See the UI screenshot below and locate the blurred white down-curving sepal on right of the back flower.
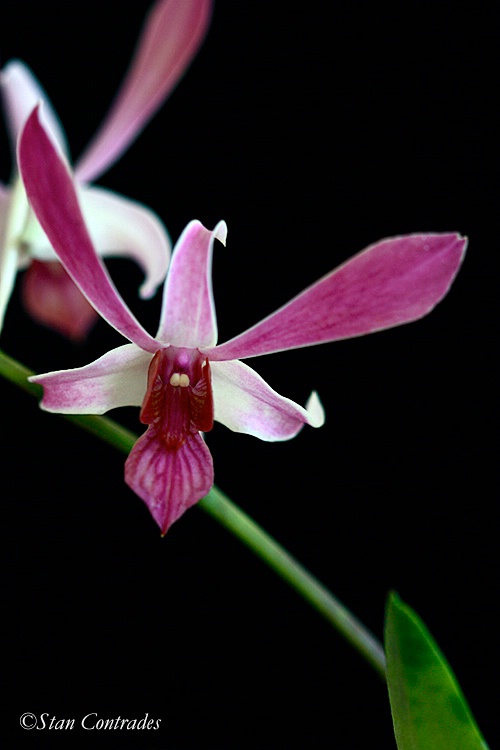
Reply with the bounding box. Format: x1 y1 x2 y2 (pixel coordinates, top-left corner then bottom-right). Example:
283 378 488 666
78 187 172 299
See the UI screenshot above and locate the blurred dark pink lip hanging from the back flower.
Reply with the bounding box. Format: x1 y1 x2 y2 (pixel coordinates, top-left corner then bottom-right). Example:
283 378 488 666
22 260 98 341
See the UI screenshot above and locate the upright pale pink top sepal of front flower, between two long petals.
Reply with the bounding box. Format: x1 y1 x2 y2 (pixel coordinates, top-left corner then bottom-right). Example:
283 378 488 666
156 221 227 348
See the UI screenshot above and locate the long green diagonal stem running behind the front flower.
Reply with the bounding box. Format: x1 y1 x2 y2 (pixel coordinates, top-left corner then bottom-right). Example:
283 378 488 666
0 351 385 679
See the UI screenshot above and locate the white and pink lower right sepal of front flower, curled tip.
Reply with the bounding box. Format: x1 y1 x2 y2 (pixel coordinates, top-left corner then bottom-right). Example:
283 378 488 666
212 360 325 441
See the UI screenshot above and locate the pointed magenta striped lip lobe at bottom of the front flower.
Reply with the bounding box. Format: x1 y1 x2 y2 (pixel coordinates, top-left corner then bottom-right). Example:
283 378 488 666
125 427 214 534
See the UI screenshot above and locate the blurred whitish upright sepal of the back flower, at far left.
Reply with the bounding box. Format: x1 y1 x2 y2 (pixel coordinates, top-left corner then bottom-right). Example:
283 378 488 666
0 60 68 160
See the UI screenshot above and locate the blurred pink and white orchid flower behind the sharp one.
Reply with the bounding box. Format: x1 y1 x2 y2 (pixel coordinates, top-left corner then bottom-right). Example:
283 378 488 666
0 0 212 340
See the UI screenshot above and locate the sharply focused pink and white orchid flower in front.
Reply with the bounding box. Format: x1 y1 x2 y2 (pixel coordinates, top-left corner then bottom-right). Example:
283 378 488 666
19 111 466 533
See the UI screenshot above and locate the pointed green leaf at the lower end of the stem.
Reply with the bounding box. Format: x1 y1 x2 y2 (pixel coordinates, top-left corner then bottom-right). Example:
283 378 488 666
385 593 488 750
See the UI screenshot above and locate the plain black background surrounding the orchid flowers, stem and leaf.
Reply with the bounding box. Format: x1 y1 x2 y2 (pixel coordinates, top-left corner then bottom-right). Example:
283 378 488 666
0 0 499 750
